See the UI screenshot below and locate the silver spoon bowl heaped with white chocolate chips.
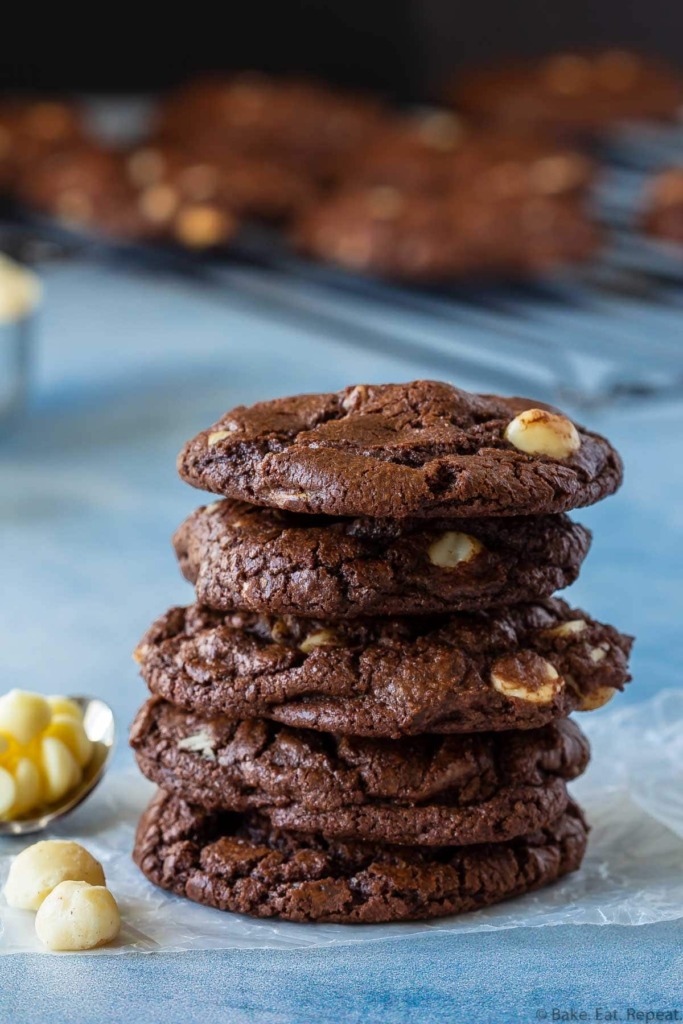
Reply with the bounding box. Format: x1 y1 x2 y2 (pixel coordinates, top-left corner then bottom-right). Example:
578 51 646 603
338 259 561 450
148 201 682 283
0 690 116 837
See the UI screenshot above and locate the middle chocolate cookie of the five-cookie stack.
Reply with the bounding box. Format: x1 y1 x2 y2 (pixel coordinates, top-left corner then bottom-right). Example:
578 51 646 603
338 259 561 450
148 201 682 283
135 599 632 737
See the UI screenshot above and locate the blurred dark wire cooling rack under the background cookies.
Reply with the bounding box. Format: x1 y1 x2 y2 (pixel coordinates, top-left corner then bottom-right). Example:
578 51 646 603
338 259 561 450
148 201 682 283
0 117 683 404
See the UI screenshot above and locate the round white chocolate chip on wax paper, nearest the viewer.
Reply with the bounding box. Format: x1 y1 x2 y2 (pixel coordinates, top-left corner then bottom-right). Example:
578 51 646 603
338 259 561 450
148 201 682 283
36 882 121 950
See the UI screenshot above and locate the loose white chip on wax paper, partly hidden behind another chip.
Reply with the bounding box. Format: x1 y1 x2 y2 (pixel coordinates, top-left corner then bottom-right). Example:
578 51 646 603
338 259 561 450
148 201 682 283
5 840 104 910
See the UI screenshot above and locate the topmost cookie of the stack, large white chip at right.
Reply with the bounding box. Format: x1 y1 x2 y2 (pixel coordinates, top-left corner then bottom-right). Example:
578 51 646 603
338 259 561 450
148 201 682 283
178 381 622 518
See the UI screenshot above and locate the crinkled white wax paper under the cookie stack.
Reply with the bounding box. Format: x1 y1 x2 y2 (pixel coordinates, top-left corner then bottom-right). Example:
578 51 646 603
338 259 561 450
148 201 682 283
0 690 683 953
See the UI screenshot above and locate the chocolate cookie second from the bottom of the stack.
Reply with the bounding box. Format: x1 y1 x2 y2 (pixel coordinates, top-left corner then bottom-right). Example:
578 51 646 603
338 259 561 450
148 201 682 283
130 699 589 846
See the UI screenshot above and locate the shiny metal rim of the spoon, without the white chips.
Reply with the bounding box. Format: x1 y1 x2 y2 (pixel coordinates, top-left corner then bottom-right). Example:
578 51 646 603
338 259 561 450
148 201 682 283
0 696 116 836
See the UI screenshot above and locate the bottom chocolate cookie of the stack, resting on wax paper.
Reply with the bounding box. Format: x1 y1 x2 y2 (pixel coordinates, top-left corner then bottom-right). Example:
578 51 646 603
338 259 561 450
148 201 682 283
133 793 588 924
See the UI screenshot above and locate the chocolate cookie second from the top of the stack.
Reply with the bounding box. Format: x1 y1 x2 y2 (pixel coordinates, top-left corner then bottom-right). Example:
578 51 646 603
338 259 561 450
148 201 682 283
173 499 591 618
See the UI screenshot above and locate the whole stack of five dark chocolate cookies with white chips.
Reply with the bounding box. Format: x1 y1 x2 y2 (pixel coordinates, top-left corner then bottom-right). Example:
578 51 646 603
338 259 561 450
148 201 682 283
131 381 631 922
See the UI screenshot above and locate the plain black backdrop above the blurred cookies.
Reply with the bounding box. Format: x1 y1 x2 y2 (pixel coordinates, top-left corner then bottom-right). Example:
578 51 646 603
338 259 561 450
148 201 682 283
0 0 683 98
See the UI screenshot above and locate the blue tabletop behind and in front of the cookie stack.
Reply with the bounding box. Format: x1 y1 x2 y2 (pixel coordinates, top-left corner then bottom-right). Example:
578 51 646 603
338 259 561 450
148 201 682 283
0 263 683 1024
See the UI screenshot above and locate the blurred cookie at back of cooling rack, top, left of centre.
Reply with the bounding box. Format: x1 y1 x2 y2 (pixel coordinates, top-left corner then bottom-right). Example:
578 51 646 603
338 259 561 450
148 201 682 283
156 73 383 179
